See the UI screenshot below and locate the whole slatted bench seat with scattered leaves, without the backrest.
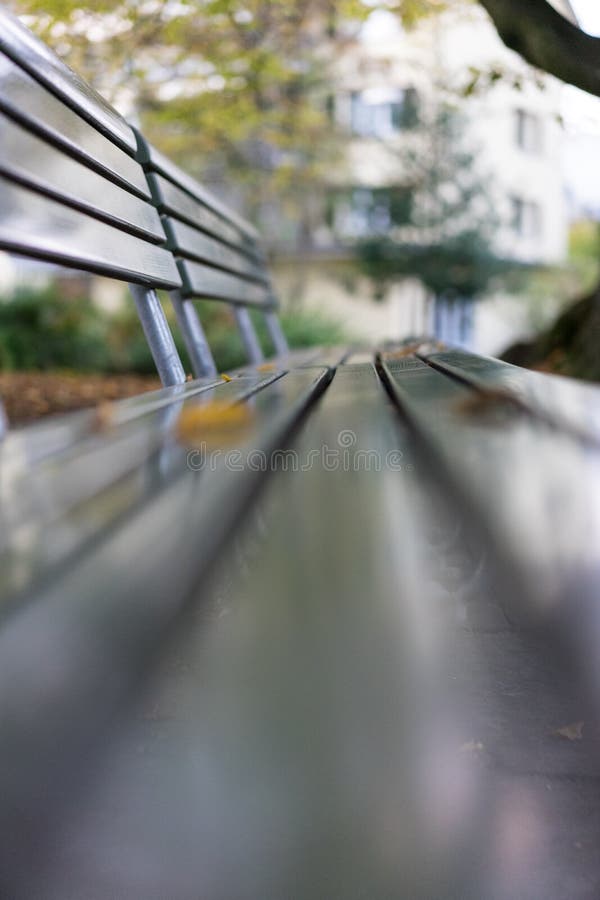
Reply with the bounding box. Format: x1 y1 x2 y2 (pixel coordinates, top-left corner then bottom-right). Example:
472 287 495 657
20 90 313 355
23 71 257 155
0 351 600 900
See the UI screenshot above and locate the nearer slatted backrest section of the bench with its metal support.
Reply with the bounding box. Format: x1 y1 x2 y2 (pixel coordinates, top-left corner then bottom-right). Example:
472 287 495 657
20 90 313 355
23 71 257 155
0 10 190 384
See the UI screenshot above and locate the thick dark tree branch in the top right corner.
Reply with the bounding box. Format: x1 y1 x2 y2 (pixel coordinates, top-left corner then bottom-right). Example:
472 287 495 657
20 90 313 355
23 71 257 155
479 0 600 96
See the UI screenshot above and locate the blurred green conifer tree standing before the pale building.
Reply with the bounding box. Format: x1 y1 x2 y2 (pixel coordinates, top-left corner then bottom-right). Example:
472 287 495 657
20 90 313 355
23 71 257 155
357 107 514 300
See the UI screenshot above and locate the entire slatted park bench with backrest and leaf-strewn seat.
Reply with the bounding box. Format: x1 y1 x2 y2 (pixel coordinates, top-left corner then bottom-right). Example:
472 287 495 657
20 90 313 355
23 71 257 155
0 12 600 900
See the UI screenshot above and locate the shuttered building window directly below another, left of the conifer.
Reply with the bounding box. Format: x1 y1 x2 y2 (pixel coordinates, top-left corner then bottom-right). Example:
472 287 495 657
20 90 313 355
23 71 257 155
327 187 412 239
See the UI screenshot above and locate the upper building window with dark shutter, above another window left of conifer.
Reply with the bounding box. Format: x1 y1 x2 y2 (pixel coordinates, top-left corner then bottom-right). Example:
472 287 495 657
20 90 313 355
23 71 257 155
350 87 418 138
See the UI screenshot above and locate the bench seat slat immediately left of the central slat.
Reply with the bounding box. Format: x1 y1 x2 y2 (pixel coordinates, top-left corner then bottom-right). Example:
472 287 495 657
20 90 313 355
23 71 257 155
0 369 330 896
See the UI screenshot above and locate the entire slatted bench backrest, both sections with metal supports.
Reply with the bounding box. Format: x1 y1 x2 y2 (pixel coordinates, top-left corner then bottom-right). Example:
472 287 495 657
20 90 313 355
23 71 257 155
0 9 287 398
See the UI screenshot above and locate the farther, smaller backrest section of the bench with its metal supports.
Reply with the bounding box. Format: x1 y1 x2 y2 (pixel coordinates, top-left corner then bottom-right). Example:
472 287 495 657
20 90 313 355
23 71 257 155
138 135 287 375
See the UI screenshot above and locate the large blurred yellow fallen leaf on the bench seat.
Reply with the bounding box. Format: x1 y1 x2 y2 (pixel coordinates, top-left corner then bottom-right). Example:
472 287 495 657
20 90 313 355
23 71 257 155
176 400 254 447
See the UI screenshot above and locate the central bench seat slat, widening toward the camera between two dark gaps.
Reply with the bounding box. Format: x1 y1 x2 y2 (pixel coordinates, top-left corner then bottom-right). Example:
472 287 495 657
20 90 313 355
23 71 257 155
57 371 599 900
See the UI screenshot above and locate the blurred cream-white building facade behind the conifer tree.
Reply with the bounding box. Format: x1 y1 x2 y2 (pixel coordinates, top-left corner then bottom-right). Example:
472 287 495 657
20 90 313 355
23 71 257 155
275 2 572 352
